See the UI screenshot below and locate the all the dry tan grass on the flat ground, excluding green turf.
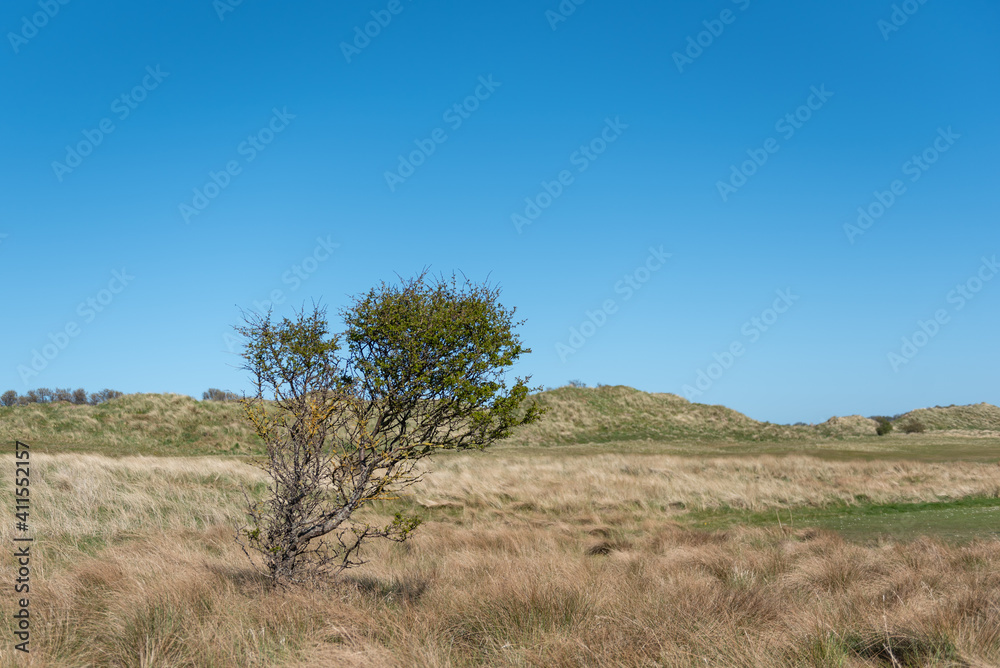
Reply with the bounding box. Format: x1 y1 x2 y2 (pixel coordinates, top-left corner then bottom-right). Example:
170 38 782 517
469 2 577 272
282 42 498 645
0 451 1000 668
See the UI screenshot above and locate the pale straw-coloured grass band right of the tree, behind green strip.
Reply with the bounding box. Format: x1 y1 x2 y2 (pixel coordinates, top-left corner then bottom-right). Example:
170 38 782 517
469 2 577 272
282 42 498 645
415 450 1000 515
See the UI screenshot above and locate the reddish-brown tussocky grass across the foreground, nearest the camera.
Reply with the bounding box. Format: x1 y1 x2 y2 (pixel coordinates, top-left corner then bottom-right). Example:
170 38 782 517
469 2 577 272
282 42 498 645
2 522 1000 668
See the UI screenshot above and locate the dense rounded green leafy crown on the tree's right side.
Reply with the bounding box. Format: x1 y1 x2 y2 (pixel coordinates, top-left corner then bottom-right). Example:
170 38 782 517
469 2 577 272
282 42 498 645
342 272 541 449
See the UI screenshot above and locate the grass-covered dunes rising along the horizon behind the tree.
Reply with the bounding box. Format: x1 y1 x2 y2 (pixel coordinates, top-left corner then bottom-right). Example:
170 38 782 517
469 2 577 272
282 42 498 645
0 385 1000 455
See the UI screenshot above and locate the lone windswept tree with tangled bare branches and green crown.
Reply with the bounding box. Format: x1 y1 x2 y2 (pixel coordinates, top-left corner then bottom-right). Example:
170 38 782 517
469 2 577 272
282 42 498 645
236 271 542 584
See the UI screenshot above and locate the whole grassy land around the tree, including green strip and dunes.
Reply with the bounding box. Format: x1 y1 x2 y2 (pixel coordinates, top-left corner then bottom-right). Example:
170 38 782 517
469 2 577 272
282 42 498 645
0 388 1000 668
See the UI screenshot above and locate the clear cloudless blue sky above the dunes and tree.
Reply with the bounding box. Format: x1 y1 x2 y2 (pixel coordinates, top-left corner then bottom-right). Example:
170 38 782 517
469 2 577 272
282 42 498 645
0 0 1000 422
